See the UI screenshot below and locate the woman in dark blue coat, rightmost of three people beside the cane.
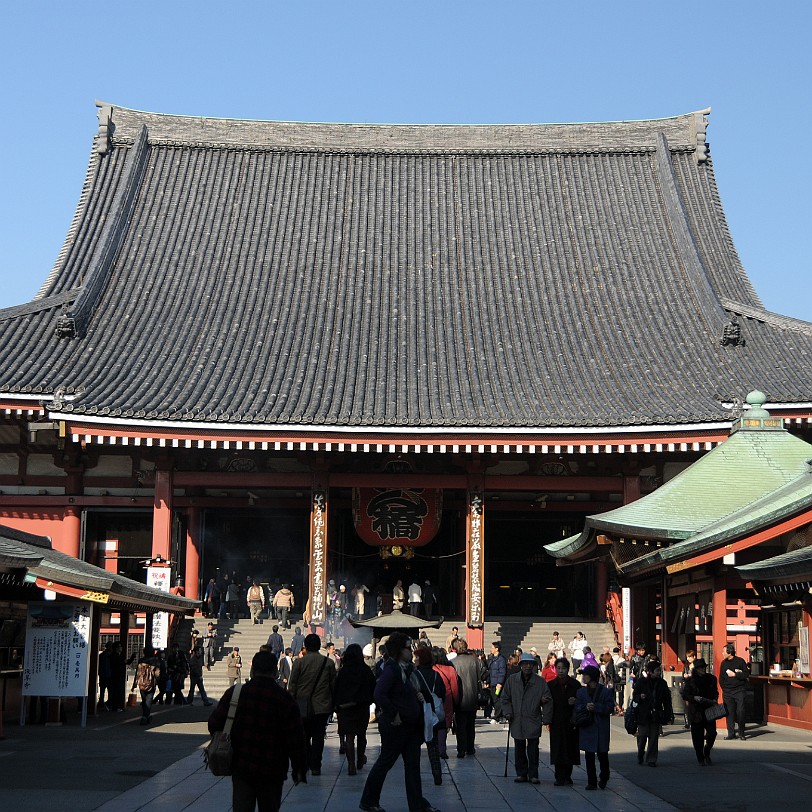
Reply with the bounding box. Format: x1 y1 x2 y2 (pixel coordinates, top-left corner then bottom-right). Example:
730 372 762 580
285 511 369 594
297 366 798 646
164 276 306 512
572 665 615 789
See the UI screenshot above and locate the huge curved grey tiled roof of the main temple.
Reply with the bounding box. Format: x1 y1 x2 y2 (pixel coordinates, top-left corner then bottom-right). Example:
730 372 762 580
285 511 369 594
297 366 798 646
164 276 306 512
0 107 812 431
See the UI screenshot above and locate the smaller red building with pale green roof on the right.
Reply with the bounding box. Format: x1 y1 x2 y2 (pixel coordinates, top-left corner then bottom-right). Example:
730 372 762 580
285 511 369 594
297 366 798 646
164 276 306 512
545 392 812 730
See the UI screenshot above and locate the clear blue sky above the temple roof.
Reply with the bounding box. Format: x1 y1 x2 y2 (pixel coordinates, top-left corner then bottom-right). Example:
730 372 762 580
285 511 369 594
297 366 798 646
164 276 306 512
0 0 812 320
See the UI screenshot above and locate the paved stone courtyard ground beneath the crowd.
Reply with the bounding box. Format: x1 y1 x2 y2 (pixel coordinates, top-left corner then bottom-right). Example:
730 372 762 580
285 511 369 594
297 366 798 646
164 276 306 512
0 704 812 812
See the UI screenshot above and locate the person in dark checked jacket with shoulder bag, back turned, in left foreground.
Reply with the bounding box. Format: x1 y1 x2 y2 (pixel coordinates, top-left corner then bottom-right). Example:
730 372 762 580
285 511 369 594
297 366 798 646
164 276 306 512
209 651 307 812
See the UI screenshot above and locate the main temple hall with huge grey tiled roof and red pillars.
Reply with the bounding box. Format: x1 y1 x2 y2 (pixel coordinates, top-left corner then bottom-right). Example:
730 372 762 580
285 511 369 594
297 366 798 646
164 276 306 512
0 103 812 647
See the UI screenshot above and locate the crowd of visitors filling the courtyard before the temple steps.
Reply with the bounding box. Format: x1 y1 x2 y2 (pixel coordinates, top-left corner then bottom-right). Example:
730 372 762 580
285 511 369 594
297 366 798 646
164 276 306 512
116 583 749 812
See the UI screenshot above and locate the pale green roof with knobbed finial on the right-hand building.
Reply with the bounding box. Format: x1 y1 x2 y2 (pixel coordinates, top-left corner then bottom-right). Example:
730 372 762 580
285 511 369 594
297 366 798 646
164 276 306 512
544 392 812 576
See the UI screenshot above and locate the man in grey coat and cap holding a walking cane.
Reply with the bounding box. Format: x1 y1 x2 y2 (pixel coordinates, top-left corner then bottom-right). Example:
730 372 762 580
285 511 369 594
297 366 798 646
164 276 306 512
502 652 553 784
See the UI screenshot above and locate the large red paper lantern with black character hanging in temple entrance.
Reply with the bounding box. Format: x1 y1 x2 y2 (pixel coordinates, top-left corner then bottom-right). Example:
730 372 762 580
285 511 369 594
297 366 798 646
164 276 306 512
352 487 443 547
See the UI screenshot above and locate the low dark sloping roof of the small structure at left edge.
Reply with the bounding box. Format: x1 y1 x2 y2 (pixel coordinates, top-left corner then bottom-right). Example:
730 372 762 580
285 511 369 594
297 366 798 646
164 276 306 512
0 525 199 614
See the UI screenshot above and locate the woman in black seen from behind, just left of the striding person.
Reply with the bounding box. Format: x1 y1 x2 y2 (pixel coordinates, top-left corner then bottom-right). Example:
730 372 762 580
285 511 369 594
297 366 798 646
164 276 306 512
333 643 375 775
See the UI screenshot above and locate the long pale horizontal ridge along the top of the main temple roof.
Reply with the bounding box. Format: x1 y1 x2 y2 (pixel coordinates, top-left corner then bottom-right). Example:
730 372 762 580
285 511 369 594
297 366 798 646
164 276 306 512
96 102 710 154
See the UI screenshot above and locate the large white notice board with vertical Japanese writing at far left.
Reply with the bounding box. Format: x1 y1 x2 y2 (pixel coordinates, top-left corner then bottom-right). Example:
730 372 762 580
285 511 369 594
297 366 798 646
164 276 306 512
22 601 93 696
